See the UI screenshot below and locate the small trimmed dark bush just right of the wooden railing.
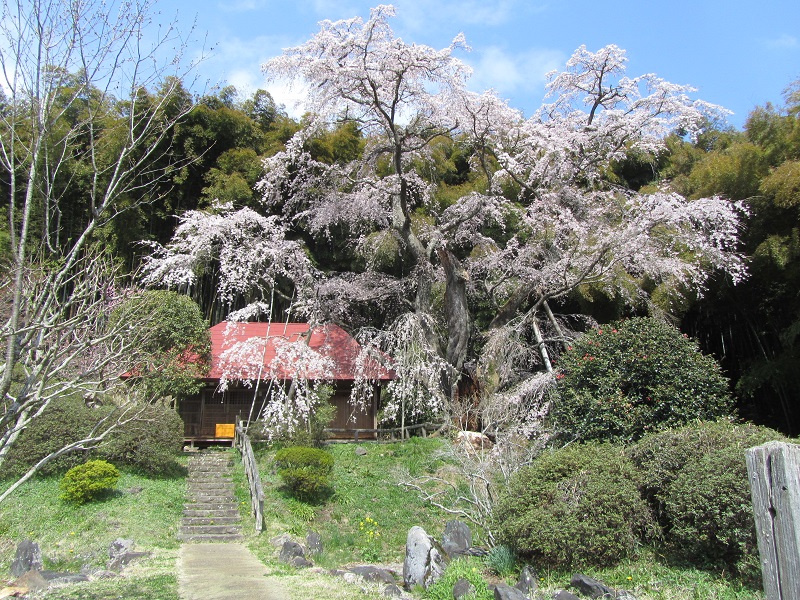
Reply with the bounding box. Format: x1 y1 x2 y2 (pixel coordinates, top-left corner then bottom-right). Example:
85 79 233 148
275 446 333 501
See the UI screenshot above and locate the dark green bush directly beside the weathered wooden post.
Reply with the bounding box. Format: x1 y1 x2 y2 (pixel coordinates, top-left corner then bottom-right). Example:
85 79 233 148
627 420 785 574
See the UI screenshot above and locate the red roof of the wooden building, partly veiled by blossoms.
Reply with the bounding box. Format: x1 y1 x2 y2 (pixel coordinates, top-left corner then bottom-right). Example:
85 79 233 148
206 321 395 381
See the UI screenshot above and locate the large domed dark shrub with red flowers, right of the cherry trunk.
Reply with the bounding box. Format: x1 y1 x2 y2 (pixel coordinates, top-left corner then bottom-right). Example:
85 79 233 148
550 318 733 442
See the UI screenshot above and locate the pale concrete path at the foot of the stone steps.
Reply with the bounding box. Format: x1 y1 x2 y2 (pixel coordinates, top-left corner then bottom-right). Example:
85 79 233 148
178 543 289 600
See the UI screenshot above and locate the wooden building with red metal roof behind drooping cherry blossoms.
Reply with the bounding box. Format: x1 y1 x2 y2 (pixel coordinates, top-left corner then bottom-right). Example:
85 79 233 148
178 321 394 444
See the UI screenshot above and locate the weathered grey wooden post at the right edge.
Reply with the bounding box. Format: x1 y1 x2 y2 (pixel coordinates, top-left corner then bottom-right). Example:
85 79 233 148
746 442 800 600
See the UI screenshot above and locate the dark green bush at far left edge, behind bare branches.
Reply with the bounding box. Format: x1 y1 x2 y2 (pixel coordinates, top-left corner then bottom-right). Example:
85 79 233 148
3 397 108 477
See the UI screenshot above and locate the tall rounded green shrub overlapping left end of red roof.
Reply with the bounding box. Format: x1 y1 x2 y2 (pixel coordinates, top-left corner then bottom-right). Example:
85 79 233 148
111 290 211 398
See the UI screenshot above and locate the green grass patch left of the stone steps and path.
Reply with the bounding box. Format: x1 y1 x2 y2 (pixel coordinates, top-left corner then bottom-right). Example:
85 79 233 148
0 462 186 600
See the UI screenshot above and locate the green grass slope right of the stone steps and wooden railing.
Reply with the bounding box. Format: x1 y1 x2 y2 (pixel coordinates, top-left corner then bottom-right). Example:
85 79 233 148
236 438 454 567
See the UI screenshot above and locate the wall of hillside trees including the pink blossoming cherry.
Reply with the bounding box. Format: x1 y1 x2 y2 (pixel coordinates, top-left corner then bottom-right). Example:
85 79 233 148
0 0 800 464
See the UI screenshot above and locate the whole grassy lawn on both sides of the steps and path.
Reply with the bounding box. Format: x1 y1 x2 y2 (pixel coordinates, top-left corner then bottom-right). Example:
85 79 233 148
0 438 764 600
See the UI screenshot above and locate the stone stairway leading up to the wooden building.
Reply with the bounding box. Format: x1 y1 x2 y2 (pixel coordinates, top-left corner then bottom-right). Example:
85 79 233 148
178 452 243 542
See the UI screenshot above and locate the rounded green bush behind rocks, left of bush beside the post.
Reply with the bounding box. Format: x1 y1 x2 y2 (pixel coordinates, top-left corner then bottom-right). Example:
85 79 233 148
494 443 652 568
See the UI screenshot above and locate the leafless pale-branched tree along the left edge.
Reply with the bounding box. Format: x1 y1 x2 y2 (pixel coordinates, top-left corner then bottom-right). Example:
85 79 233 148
0 0 203 497
